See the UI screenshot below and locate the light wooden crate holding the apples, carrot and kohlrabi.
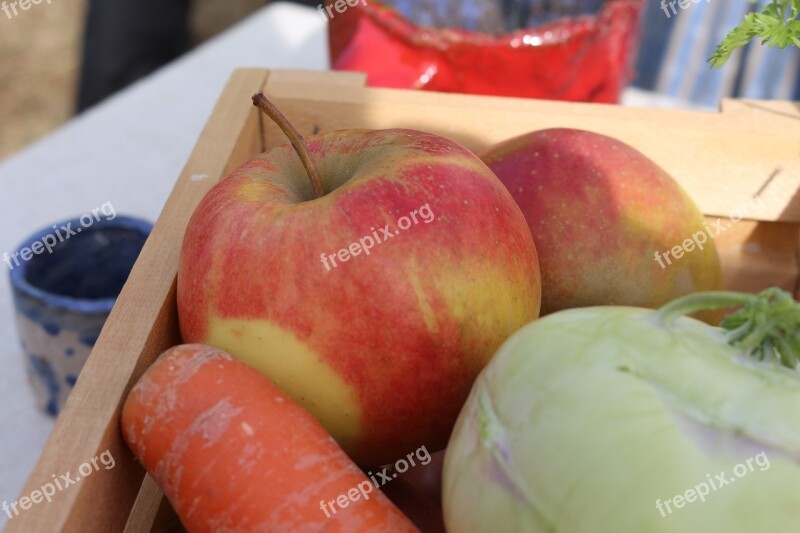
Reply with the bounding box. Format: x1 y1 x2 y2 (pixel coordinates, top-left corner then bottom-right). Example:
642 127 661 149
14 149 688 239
7 69 800 533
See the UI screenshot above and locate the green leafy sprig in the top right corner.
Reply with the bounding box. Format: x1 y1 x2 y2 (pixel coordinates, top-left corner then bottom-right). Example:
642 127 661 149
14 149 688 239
708 0 800 68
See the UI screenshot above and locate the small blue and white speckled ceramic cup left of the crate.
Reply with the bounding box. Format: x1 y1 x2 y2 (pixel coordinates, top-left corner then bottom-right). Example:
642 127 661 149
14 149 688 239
8 214 152 415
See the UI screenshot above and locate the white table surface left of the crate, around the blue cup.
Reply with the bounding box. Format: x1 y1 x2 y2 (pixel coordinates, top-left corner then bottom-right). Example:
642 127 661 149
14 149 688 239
0 3 328 529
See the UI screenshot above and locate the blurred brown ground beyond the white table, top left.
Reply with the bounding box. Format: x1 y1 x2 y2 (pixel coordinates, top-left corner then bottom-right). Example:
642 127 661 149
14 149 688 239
0 0 267 160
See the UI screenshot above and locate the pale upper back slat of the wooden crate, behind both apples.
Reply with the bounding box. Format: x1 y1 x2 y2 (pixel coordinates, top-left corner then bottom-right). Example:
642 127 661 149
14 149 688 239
265 69 800 223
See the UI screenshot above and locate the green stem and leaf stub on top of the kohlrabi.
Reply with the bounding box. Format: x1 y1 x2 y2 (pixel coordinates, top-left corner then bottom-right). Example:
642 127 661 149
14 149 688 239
657 287 800 368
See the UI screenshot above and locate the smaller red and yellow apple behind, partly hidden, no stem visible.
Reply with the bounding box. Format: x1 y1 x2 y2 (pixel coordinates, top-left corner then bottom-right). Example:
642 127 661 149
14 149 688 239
481 129 722 319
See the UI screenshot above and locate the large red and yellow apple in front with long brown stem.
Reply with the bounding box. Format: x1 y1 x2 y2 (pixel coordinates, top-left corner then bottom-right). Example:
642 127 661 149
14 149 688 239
178 96 540 465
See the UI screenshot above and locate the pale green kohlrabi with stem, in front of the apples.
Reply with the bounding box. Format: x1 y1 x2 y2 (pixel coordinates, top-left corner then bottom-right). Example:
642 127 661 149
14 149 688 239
443 289 800 533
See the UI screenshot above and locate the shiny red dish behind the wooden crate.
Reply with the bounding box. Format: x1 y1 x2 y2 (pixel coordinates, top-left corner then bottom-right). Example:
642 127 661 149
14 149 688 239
328 0 643 103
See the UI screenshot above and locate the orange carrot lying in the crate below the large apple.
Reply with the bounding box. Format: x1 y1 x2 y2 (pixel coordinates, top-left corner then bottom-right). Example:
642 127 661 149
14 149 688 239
122 344 418 533
